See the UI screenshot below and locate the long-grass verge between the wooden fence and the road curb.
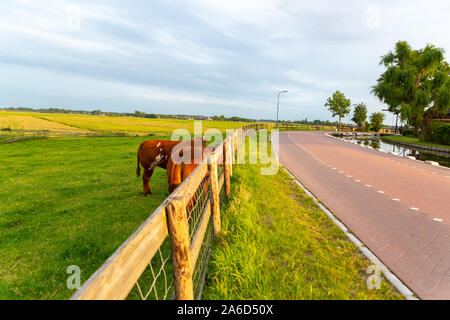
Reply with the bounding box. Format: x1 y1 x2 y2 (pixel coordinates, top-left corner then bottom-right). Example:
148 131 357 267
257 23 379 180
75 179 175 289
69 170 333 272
203 139 402 299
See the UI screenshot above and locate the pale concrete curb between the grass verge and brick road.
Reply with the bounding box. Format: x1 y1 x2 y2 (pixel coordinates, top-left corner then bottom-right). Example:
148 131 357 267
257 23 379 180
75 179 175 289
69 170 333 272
270 132 420 300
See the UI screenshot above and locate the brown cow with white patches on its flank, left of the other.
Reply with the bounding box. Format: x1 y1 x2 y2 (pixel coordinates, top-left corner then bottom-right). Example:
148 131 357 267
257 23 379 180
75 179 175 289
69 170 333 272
136 139 205 195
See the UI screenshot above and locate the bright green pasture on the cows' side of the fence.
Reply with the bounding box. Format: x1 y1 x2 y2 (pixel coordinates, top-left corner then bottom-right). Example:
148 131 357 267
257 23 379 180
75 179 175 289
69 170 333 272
0 137 168 299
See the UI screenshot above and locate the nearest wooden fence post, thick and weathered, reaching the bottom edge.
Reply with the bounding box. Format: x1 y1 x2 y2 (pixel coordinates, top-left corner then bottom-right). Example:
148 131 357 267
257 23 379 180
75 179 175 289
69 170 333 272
167 197 194 300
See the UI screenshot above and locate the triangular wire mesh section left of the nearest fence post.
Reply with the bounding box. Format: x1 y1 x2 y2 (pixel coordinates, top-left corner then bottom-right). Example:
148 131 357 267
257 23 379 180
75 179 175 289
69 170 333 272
127 237 174 300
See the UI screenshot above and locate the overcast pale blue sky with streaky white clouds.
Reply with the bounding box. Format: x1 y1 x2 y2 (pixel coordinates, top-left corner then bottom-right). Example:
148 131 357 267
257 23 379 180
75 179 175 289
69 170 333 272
0 0 450 124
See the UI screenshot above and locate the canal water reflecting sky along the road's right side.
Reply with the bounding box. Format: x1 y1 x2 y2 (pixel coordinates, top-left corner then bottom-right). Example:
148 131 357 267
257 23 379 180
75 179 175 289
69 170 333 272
341 136 450 168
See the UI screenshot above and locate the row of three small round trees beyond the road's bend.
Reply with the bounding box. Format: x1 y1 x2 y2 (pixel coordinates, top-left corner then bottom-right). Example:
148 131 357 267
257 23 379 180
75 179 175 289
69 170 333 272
325 90 385 132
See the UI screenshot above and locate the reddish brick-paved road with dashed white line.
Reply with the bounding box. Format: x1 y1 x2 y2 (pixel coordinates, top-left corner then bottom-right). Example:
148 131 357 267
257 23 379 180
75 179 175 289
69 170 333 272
279 132 450 299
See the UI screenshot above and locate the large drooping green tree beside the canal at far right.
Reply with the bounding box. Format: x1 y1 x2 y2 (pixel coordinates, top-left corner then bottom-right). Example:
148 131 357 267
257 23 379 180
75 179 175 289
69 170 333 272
372 41 450 140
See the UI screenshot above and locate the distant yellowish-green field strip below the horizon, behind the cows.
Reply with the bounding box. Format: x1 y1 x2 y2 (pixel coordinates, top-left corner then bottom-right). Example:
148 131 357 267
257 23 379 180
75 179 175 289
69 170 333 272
0 111 249 135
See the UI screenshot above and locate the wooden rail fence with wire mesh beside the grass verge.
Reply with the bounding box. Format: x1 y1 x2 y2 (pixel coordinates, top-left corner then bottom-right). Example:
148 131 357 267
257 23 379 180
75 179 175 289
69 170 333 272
71 125 263 300
